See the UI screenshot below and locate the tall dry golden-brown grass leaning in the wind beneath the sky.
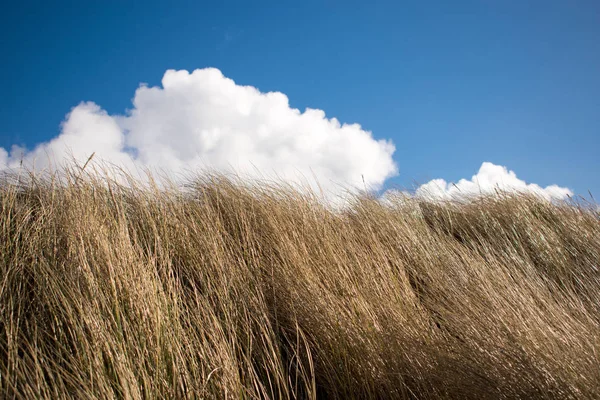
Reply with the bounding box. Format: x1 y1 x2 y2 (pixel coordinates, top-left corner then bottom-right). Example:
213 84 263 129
0 167 600 399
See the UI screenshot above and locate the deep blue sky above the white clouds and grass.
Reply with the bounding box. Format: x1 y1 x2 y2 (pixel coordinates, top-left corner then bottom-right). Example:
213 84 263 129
0 0 600 197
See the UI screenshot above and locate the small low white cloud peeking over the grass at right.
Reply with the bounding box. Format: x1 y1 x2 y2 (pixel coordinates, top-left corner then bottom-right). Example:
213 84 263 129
415 162 573 200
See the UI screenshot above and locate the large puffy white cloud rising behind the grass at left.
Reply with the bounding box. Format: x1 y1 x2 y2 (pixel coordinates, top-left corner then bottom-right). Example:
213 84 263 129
0 68 397 200
